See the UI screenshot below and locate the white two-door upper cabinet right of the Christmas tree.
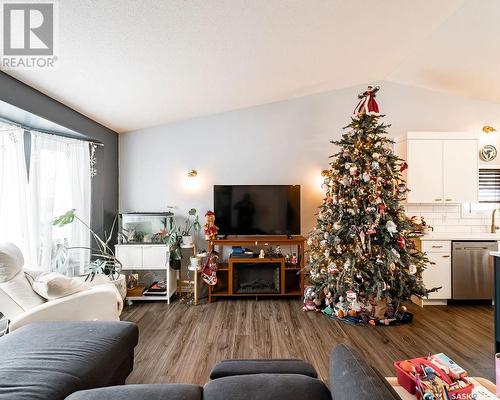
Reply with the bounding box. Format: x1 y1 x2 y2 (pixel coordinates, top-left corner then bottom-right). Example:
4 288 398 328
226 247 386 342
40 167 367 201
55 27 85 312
395 132 479 204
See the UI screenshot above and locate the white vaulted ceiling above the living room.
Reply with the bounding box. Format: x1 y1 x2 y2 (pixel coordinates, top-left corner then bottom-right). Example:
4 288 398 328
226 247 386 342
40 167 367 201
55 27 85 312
6 0 500 132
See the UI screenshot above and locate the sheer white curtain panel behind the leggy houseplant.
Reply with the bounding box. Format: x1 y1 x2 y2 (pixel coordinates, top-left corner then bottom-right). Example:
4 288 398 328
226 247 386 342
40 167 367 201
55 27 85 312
28 132 91 275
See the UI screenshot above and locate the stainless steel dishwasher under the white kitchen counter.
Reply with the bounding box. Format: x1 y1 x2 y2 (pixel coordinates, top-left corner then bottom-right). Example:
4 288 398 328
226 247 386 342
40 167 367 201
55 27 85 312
451 241 498 300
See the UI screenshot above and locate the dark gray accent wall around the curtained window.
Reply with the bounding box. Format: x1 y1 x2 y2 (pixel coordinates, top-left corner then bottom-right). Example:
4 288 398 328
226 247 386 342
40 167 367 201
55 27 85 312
0 71 118 241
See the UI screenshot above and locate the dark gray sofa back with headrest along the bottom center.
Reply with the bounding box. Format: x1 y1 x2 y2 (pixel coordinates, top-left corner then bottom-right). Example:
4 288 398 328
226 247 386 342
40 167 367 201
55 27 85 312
67 345 399 400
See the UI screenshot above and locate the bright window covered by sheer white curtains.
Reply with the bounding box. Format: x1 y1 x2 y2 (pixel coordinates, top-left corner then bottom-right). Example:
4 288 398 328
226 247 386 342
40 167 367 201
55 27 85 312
0 128 91 275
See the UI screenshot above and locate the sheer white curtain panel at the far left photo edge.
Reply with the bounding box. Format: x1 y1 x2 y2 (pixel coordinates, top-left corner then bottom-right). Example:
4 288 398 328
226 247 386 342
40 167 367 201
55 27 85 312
0 123 36 265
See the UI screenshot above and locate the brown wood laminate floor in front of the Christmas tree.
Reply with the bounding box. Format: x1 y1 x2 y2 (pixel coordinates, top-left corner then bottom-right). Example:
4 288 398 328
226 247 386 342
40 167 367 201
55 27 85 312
122 299 494 384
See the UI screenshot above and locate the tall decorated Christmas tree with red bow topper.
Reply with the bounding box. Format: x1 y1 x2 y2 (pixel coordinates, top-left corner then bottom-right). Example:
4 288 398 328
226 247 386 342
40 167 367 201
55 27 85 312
307 86 429 324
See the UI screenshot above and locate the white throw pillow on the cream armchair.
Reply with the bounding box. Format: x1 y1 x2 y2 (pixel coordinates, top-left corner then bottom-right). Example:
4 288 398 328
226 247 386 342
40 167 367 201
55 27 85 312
24 271 87 300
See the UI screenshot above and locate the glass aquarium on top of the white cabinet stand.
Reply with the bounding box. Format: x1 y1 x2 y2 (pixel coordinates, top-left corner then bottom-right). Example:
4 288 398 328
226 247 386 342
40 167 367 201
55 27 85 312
118 212 172 244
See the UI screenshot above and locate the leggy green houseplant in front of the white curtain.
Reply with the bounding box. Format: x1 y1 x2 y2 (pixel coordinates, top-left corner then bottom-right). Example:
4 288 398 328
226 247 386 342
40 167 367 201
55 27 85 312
52 209 122 281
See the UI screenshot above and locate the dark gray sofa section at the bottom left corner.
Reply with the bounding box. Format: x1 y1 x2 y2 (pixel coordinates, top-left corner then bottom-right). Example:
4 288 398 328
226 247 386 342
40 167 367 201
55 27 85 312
0 321 139 400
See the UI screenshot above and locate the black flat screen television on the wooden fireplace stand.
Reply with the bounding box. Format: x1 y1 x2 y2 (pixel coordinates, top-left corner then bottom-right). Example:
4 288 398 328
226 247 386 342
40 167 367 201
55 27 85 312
214 185 300 235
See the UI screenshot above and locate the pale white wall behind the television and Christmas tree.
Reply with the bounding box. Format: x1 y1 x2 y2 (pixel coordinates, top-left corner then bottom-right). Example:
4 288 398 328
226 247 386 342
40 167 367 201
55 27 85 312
119 82 500 238
